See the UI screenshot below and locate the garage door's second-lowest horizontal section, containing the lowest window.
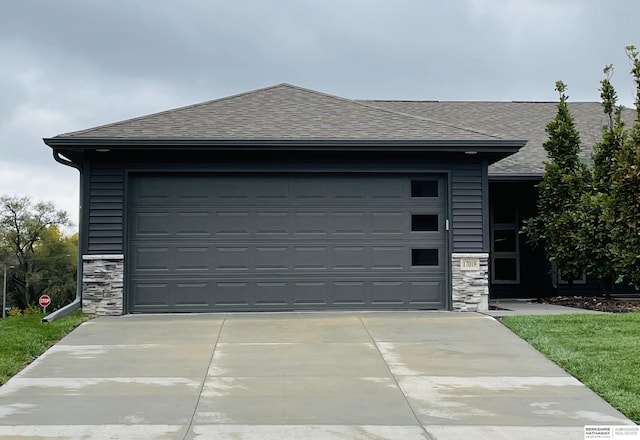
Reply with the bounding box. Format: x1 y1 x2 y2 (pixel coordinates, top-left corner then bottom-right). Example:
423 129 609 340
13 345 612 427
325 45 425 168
131 241 444 276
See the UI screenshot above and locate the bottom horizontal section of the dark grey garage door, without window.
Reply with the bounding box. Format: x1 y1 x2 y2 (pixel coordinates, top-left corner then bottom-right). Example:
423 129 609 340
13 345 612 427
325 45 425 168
131 277 444 312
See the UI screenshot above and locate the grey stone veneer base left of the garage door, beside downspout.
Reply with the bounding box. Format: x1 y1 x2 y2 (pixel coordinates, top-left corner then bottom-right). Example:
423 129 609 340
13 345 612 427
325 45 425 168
82 255 124 315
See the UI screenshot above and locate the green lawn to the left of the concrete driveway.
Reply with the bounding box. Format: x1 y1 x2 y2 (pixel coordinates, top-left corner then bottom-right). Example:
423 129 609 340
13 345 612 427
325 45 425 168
0 311 89 385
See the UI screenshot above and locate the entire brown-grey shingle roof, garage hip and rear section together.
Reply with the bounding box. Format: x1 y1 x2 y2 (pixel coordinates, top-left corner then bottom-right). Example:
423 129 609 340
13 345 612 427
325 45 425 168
55 84 635 177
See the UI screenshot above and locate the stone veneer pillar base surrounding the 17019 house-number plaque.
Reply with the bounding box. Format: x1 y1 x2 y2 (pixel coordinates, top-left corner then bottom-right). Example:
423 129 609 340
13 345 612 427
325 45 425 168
451 253 489 312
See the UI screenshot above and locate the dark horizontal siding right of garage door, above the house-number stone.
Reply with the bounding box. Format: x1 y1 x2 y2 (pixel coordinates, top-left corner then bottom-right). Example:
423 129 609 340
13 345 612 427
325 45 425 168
450 161 488 252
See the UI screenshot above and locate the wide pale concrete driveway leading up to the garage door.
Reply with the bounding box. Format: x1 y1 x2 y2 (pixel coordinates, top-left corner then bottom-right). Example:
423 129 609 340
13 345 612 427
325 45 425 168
0 312 632 440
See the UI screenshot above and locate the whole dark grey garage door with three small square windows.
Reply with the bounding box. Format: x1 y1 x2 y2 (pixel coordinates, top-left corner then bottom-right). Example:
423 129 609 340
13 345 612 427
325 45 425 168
127 175 448 312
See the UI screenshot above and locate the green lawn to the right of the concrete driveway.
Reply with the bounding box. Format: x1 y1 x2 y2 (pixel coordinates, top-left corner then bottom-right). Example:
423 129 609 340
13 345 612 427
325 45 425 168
502 313 640 423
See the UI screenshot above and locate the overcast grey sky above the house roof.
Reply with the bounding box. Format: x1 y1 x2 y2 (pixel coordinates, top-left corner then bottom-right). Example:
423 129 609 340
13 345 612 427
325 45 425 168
0 0 640 227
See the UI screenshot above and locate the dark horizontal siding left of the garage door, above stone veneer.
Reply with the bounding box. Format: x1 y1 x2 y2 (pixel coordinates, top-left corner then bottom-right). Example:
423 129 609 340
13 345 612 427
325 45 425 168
87 165 125 254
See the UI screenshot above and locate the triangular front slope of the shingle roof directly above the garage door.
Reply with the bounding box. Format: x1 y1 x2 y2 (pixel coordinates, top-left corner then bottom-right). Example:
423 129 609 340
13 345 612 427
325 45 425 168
56 84 496 140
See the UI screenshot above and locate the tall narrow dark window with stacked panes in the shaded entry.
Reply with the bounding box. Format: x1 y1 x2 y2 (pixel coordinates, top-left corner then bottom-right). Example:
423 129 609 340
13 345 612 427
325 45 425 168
491 202 520 284
